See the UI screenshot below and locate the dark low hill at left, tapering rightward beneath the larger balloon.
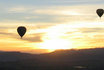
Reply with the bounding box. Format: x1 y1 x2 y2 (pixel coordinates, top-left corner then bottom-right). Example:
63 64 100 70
0 52 37 62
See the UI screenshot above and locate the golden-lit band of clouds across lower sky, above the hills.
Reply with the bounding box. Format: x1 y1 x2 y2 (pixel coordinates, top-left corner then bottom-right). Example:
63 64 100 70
0 22 104 53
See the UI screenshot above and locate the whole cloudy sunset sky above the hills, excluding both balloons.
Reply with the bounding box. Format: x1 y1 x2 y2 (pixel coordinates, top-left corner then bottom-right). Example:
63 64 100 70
0 0 104 53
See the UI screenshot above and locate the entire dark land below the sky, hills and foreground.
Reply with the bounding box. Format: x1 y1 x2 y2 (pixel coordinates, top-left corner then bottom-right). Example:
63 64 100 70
0 48 104 70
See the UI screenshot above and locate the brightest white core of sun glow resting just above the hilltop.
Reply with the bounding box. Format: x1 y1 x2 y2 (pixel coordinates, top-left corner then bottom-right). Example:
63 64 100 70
42 39 72 49
